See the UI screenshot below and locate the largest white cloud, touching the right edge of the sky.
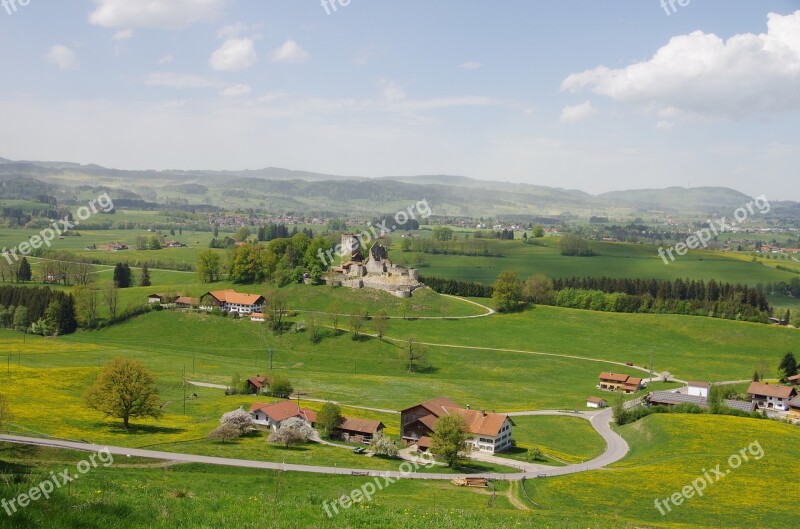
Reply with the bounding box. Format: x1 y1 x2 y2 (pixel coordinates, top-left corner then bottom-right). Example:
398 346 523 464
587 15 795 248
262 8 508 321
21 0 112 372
561 11 800 118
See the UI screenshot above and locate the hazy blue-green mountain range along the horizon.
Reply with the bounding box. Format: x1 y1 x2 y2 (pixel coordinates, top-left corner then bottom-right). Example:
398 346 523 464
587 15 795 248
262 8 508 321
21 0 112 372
0 158 800 221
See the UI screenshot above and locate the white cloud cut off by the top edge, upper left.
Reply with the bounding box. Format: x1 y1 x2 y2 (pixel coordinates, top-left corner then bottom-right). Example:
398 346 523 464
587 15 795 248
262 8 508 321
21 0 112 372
89 0 229 29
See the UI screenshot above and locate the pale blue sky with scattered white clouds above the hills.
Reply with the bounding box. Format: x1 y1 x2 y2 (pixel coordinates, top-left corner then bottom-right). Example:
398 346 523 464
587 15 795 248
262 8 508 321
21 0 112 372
0 0 800 200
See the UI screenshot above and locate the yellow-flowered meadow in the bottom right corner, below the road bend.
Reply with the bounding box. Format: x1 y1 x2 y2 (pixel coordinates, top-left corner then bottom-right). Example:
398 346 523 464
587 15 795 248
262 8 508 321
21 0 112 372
526 415 800 529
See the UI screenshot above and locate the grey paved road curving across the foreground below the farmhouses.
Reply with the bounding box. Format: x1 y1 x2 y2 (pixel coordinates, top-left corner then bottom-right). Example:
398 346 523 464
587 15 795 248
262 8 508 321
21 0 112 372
0 409 628 481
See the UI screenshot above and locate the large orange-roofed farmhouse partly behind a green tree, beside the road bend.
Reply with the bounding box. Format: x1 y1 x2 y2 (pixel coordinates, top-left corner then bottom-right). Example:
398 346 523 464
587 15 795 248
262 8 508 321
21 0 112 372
400 397 514 453
